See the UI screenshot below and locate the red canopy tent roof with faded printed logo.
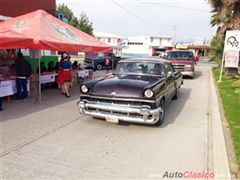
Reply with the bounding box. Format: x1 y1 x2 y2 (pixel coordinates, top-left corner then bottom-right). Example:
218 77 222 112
0 10 113 52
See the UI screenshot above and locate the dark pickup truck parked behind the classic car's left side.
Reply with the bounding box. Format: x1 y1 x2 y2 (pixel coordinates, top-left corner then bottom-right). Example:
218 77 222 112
84 53 121 70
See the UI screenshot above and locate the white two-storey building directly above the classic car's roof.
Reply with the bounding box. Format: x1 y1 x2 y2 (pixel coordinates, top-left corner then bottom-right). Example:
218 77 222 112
122 35 173 56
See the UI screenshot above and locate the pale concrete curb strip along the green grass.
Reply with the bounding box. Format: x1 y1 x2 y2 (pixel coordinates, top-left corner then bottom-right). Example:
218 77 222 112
209 69 232 180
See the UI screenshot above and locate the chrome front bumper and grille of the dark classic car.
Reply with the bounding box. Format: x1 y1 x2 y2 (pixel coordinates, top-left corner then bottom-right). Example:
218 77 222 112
78 100 162 124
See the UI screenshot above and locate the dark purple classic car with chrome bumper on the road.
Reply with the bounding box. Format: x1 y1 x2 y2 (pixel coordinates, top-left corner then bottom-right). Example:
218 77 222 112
78 58 182 126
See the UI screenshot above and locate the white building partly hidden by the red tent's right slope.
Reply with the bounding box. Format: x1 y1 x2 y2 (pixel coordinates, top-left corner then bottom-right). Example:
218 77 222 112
93 31 124 57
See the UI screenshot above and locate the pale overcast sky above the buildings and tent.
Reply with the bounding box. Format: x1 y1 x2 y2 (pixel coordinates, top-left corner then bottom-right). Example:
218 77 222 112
56 0 216 42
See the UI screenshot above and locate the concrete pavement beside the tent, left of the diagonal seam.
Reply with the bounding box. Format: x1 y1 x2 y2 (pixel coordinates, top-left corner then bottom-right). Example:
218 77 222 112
0 70 110 155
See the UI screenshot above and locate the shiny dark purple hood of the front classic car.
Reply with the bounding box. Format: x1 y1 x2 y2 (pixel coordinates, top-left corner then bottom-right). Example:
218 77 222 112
91 75 161 98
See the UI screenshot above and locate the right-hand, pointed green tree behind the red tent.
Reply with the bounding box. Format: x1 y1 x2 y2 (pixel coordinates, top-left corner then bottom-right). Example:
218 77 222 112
78 12 93 35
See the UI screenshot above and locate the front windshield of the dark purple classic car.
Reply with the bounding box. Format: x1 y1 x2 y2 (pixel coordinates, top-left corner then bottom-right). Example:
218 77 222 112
115 62 164 76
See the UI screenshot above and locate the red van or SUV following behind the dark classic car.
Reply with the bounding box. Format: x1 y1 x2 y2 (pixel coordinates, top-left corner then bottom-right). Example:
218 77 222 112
166 50 195 78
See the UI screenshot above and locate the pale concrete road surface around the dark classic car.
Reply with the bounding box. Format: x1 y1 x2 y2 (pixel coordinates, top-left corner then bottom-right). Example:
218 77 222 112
1 63 216 180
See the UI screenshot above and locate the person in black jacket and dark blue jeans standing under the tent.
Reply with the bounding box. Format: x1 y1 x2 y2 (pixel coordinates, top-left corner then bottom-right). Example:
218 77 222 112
15 52 32 100
